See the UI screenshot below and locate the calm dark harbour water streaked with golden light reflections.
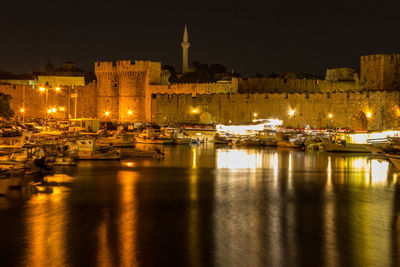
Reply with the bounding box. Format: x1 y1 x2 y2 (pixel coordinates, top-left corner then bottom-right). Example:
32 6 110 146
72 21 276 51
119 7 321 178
0 146 400 266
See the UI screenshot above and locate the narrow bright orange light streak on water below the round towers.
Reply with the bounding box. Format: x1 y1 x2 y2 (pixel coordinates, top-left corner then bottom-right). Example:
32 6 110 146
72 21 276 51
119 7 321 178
117 171 139 266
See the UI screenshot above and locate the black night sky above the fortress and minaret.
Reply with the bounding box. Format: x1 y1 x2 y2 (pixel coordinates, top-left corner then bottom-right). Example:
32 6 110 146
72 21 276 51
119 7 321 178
0 0 400 75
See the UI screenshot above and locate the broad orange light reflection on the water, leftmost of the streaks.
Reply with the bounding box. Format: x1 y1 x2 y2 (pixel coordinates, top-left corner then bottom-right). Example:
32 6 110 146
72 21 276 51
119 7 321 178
26 185 68 267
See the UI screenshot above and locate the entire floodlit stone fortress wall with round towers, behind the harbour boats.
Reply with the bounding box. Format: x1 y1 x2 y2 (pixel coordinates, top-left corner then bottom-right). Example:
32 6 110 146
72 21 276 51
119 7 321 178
0 54 400 129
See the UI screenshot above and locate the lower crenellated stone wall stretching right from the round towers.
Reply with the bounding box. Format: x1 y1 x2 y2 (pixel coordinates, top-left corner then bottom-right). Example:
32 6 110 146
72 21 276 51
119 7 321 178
152 91 400 130
